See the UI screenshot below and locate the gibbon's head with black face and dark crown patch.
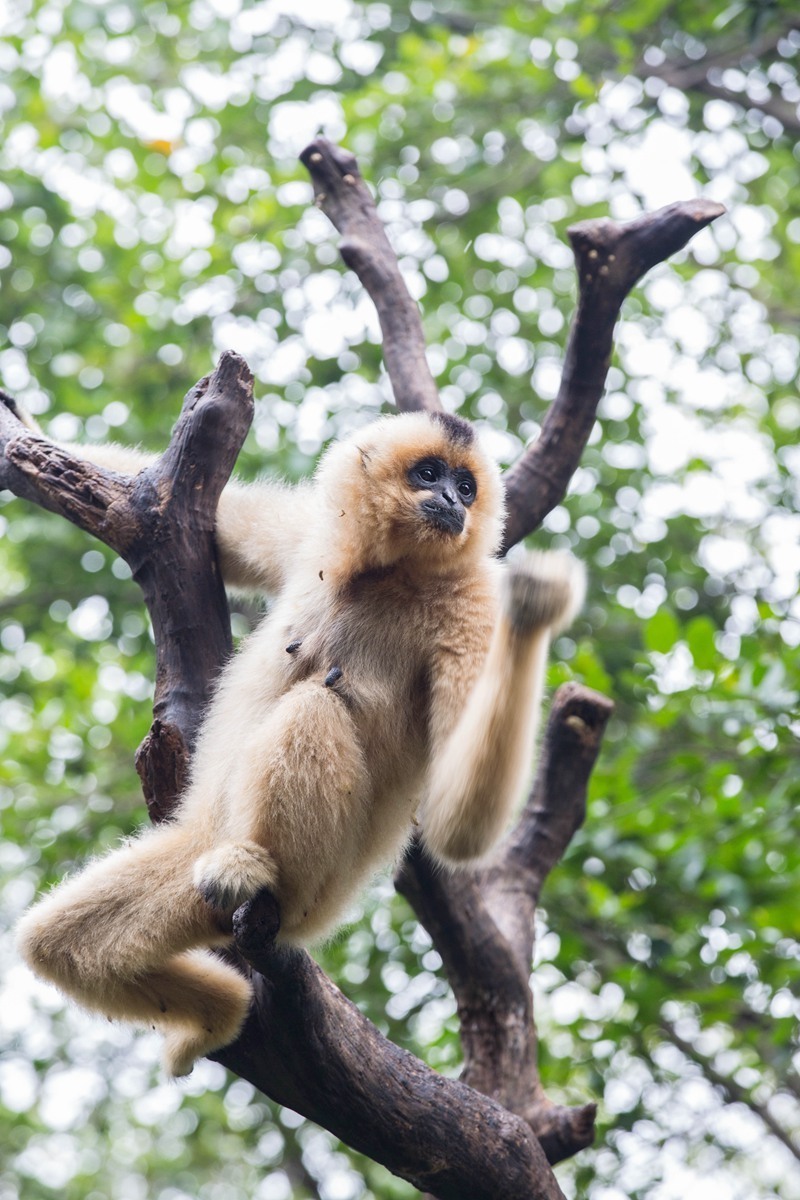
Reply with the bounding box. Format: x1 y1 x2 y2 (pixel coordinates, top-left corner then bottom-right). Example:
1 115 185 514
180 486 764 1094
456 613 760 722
318 413 505 569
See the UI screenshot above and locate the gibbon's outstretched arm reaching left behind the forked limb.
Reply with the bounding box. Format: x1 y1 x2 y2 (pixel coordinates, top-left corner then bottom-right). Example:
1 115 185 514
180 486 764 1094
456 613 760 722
17 415 315 594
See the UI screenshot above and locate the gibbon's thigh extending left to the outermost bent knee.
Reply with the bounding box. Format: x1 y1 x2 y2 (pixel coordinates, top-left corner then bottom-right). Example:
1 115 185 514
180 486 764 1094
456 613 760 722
17 824 230 988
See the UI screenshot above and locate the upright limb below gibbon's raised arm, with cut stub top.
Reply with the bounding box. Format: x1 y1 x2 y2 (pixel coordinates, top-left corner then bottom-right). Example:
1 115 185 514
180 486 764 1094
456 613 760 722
396 684 612 1163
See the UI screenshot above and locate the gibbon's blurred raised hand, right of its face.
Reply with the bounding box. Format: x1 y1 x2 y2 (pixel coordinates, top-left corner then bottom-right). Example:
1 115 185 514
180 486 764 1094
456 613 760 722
505 551 587 634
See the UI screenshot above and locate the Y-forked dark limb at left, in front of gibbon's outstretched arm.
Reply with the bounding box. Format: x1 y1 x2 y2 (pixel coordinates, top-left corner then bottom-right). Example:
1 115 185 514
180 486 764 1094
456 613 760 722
0 354 253 820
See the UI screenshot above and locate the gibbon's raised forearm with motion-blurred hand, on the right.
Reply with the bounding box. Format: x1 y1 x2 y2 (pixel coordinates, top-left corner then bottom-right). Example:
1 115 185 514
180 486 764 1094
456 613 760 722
422 552 585 862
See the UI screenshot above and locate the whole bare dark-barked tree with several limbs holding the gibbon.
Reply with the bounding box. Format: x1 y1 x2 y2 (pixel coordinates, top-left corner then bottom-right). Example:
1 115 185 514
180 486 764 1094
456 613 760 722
0 139 722 1200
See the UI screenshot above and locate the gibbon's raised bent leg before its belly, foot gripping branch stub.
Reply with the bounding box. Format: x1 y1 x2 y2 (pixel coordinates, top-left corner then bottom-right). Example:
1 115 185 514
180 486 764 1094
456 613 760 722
196 680 369 941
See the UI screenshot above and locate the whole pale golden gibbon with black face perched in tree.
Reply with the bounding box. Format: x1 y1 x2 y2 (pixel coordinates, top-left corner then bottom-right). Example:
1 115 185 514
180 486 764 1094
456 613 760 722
18 413 584 1075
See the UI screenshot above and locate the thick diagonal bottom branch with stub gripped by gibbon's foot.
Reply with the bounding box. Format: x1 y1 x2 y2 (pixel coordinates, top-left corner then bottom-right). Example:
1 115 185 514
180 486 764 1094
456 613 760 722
216 893 561 1200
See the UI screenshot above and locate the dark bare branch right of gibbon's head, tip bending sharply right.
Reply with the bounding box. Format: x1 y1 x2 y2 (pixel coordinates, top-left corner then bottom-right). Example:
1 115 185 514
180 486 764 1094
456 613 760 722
505 199 724 550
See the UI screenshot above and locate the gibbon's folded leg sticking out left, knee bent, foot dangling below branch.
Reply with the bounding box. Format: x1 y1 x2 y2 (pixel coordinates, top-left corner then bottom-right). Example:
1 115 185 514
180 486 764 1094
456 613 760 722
17 824 251 1075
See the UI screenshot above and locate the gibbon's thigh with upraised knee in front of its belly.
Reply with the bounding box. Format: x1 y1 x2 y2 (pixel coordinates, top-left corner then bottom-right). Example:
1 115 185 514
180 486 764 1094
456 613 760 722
221 680 369 902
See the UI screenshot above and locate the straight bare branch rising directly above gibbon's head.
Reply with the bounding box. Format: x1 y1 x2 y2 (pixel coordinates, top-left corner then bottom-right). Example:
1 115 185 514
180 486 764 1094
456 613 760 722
300 138 441 412
